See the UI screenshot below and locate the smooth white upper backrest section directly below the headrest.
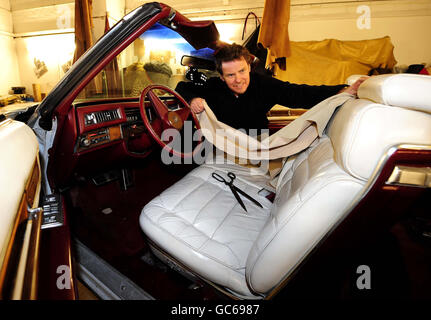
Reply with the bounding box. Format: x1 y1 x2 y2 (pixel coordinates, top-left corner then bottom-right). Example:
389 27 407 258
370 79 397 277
327 97 431 181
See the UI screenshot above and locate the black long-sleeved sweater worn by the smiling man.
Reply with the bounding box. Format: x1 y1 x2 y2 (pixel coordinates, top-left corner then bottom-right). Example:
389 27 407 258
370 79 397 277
175 73 345 131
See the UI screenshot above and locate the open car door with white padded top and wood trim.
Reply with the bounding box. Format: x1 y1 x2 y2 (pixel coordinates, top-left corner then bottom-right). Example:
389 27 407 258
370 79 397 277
0 119 42 299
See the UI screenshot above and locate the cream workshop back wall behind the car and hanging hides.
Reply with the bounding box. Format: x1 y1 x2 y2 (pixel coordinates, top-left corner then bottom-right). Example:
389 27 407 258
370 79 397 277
5 0 431 94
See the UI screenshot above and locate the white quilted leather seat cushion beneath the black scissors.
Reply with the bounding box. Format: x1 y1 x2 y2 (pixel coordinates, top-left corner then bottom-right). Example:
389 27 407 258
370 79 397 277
140 165 272 296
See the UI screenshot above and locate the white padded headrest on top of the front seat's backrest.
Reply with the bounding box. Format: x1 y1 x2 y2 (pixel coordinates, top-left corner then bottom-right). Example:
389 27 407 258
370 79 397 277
358 73 431 113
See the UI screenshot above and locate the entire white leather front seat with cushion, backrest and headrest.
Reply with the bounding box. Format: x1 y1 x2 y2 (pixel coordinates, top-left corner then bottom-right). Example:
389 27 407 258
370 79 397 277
140 74 431 298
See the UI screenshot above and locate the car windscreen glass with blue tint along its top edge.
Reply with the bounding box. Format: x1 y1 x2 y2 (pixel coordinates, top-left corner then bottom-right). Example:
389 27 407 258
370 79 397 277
76 23 213 102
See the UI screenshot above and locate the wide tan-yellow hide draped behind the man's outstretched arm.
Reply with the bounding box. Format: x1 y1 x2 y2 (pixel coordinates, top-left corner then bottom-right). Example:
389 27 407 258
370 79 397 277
275 37 397 85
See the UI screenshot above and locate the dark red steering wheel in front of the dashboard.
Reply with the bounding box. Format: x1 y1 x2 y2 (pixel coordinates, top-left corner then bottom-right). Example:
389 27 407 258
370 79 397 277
139 85 203 158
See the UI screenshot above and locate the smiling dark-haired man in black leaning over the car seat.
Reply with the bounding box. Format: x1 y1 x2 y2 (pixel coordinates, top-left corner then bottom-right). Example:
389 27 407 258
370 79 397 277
175 44 363 131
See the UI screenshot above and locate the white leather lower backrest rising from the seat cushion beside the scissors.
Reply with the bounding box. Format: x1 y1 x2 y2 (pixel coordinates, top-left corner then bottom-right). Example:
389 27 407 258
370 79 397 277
246 136 364 293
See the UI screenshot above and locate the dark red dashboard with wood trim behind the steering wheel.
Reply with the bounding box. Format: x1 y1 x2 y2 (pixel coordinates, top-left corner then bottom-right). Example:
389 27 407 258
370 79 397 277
50 96 185 188
